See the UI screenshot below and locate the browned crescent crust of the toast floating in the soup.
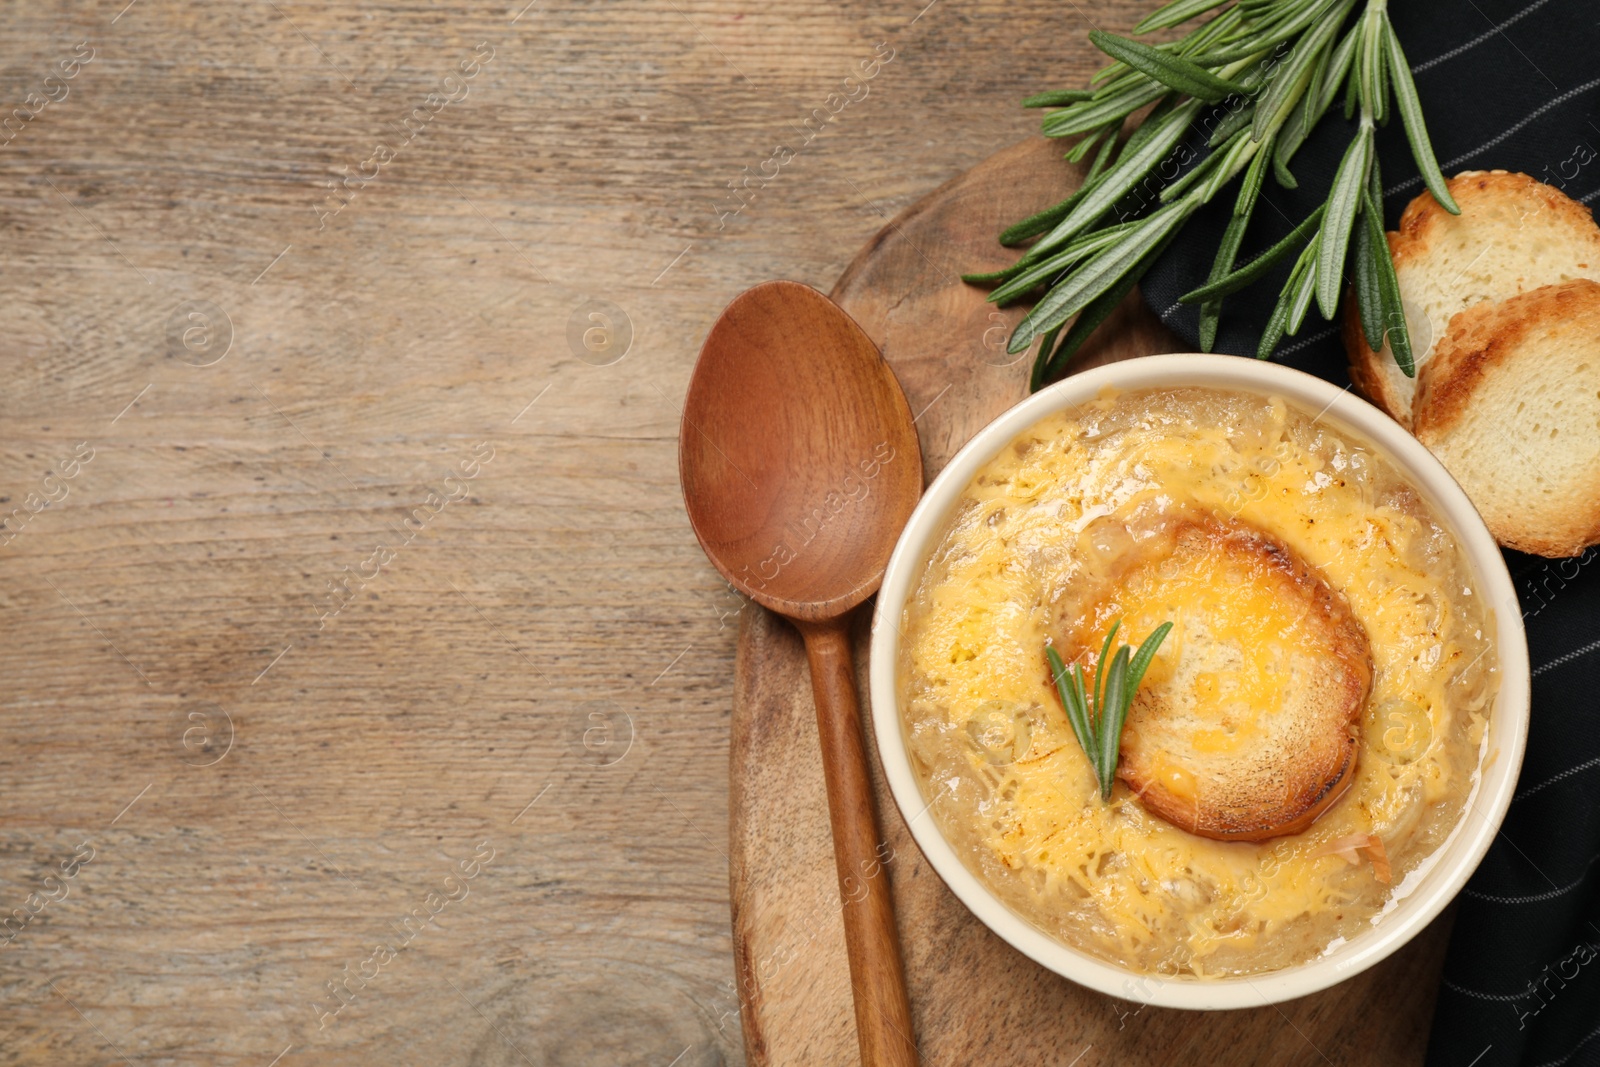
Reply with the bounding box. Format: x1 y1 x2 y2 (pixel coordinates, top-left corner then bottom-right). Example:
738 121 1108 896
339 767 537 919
1088 515 1373 841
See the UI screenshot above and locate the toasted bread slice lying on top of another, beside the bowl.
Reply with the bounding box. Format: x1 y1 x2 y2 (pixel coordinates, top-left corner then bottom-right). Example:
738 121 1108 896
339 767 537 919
1416 280 1600 557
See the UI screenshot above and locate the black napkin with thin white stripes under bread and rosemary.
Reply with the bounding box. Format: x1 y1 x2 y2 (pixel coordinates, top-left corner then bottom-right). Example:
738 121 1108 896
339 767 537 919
1142 0 1600 1067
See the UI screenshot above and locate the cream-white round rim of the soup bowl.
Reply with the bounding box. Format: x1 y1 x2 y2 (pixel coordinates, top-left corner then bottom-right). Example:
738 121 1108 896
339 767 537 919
869 354 1530 1009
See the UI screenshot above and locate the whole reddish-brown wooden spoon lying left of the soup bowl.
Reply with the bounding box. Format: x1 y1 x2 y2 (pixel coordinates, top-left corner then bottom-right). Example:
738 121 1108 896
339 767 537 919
678 282 922 1067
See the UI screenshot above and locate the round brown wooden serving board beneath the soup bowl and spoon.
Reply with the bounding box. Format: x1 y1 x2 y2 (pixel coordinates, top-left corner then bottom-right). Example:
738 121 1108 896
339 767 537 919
730 138 1450 1067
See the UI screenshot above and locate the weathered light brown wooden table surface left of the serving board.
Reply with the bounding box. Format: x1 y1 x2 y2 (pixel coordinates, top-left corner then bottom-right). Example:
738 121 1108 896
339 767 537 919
0 0 1414 1067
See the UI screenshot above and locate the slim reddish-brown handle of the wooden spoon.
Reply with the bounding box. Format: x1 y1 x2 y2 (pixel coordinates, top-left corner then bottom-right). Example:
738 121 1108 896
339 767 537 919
798 613 917 1067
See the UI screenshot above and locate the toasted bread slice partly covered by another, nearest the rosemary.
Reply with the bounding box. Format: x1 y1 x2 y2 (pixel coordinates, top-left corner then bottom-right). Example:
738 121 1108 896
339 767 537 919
1344 171 1600 427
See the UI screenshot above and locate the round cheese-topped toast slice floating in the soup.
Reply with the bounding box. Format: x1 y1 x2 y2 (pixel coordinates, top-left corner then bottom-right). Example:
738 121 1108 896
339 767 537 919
1074 515 1371 841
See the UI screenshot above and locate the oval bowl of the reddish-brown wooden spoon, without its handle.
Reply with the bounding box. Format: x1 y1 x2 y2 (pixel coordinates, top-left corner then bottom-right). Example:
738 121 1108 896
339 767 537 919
678 282 922 619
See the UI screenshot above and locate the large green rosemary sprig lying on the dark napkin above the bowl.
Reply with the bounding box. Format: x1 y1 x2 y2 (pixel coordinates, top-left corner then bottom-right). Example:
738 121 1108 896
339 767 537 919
966 0 1461 389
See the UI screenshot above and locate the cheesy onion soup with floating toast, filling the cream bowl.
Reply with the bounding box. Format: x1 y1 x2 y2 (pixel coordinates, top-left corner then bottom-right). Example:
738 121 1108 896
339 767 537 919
898 389 1498 979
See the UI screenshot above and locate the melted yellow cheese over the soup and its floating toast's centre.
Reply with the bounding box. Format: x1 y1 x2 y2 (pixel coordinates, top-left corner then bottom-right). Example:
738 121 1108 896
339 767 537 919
899 389 1498 977
